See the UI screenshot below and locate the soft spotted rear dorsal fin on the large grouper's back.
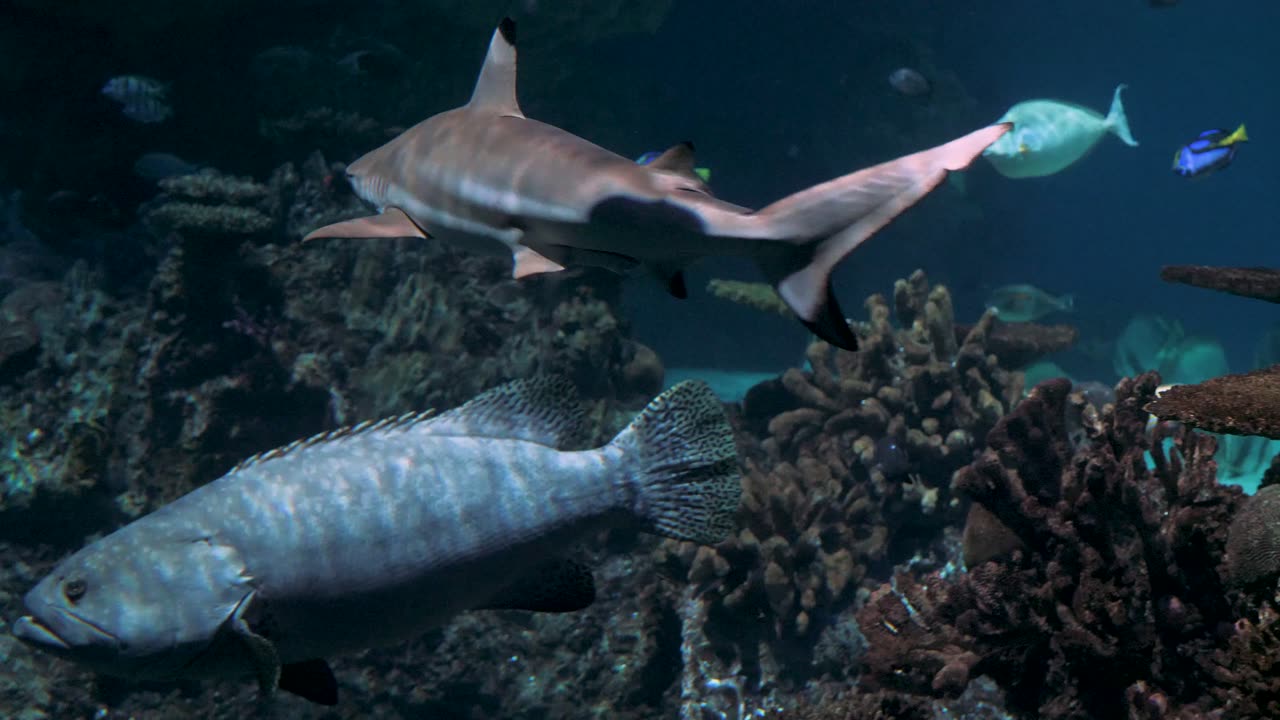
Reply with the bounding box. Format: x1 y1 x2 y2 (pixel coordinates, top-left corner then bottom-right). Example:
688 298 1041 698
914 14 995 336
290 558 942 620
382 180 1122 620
413 375 588 450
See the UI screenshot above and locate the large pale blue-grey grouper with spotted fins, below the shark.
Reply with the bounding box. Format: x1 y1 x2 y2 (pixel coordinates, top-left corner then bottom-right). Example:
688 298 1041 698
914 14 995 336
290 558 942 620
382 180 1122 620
12 378 741 705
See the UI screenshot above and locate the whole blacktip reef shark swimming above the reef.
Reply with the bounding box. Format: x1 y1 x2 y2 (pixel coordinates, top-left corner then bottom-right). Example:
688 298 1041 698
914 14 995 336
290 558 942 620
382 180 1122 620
305 18 1012 350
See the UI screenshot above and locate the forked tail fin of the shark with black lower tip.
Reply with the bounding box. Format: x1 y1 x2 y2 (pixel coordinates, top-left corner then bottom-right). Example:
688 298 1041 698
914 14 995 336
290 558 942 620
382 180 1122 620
755 123 1012 350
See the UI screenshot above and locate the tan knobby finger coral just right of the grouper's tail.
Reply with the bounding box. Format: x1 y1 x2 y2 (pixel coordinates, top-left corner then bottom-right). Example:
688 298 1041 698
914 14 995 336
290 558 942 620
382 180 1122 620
657 273 1021 716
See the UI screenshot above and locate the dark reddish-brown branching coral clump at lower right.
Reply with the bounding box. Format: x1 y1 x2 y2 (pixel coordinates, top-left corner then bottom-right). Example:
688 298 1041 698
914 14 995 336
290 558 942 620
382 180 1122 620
859 373 1242 719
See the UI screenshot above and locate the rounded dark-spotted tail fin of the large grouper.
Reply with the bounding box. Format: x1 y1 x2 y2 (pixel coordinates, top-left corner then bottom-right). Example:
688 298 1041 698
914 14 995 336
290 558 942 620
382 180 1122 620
611 380 742 544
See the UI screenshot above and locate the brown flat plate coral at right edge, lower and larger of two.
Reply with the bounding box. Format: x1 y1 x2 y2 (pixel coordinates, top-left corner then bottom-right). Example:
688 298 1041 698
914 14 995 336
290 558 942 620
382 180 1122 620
1146 365 1280 439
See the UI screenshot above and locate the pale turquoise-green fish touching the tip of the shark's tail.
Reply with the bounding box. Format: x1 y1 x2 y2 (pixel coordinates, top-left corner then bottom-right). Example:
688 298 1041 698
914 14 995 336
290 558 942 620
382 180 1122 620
982 85 1138 178
